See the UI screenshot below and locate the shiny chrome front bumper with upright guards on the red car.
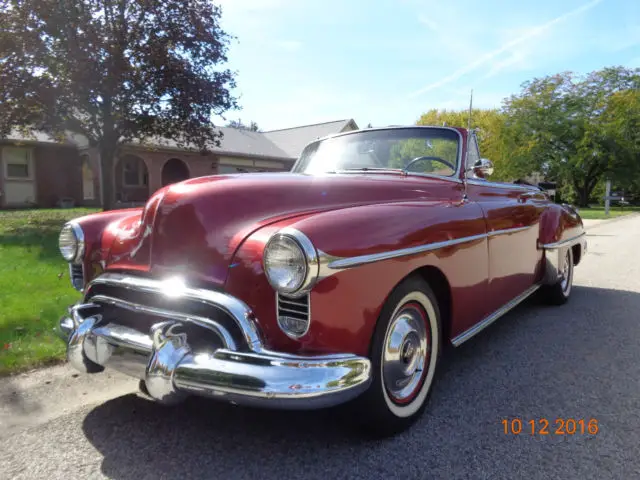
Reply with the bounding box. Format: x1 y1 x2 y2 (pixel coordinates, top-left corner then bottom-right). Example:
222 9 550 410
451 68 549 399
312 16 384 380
58 274 371 409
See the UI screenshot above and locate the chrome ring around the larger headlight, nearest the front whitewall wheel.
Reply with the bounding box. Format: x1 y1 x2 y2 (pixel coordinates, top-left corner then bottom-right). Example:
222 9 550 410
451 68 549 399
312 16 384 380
262 227 319 298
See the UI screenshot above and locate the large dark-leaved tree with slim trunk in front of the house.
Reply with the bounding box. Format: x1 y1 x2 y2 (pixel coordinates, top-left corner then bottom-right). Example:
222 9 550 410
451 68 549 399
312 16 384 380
0 0 236 209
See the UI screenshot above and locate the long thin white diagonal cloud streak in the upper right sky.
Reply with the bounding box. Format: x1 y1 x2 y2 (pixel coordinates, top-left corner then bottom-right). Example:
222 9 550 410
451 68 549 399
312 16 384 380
409 0 603 98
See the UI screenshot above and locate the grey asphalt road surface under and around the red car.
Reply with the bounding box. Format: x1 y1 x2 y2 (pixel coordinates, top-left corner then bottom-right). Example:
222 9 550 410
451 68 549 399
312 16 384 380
0 216 640 480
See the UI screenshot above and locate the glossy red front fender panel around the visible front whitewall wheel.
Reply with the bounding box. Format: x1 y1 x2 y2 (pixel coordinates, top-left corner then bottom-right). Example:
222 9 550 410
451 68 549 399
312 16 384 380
225 195 489 355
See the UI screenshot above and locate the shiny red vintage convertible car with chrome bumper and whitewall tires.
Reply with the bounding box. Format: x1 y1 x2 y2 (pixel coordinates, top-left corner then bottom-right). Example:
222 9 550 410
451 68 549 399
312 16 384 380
59 126 586 434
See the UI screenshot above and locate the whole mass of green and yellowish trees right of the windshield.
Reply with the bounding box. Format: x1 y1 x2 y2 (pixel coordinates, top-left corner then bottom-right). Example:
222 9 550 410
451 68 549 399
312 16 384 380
418 67 640 202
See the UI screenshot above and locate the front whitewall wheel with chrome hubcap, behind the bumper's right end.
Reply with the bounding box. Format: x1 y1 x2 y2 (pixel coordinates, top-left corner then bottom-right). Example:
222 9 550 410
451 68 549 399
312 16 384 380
354 278 442 436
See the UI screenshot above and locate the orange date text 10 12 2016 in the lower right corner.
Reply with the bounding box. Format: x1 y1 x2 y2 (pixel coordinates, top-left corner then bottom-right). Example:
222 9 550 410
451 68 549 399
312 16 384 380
502 418 600 435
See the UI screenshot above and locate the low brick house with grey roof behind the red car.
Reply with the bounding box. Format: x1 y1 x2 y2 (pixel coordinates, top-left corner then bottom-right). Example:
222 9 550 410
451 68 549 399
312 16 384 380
0 119 358 208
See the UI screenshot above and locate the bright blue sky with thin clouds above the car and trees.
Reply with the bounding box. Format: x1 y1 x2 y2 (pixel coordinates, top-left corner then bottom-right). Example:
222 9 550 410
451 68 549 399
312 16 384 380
214 0 640 130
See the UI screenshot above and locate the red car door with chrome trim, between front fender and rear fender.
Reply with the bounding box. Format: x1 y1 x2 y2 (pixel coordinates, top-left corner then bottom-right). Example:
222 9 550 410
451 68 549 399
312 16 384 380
467 136 547 311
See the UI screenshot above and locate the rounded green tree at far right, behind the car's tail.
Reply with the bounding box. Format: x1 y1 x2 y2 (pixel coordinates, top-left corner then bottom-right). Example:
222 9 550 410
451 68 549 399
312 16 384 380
503 67 640 207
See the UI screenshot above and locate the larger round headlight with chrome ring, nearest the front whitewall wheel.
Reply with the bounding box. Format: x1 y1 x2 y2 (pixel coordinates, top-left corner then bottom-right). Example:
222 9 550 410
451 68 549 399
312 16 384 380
264 228 318 295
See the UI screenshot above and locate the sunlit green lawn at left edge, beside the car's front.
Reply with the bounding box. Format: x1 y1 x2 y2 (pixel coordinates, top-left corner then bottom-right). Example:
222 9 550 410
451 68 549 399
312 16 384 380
0 208 96 375
